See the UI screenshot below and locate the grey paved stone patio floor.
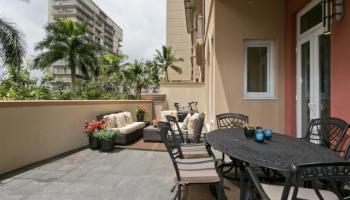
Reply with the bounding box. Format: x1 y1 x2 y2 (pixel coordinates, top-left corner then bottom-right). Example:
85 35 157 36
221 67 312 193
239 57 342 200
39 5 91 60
0 149 239 200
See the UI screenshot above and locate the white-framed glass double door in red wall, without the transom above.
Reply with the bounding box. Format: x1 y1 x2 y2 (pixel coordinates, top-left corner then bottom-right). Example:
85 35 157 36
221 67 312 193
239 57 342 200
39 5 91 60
297 29 331 137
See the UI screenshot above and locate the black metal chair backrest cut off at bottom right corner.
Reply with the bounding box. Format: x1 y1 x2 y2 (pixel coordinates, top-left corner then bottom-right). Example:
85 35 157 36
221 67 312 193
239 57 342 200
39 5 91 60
282 162 350 199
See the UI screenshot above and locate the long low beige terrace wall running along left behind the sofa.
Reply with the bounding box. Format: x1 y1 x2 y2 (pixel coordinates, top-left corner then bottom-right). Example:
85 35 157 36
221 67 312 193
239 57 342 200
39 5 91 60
0 101 153 174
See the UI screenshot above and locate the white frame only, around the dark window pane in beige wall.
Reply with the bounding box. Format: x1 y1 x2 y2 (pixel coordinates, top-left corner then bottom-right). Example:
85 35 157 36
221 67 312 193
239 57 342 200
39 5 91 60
244 40 275 99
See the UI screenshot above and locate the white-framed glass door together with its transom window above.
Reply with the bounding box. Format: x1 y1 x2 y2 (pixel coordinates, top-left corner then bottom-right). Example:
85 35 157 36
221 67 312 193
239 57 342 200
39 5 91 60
296 0 331 137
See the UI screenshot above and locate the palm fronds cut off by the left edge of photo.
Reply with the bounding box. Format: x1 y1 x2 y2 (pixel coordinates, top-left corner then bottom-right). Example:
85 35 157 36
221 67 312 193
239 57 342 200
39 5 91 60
0 18 25 69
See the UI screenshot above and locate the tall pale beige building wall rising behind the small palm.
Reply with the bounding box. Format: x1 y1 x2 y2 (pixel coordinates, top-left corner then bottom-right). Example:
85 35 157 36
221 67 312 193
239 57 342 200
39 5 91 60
166 0 192 80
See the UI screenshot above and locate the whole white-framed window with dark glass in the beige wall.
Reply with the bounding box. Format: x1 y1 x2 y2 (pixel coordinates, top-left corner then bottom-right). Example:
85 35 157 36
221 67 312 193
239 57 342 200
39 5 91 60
244 40 275 99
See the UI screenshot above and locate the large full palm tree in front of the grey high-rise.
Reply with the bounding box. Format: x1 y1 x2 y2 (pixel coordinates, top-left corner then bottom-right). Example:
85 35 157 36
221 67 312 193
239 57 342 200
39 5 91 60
34 20 101 97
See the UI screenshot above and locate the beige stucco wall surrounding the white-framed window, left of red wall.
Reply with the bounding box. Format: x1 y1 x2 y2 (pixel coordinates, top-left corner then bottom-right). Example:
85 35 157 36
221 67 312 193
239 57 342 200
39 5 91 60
213 0 285 132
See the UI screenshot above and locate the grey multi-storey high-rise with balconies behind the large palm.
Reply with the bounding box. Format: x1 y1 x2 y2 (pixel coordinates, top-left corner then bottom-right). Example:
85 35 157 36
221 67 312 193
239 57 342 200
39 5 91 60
48 0 123 86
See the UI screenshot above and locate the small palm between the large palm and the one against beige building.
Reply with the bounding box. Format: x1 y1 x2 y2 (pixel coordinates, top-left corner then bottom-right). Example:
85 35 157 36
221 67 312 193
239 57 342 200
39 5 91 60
123 60 152 99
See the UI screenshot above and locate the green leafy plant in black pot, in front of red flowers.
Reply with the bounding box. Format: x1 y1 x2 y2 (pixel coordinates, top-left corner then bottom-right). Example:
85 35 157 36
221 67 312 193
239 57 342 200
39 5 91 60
94 130 117 152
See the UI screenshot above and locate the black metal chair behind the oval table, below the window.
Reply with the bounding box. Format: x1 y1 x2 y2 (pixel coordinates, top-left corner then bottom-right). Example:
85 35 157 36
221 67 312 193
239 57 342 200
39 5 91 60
216 113 249 179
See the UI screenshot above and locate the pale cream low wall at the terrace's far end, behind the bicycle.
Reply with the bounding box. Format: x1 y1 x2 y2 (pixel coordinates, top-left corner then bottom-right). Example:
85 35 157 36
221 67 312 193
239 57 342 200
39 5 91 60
160 83 206 113
